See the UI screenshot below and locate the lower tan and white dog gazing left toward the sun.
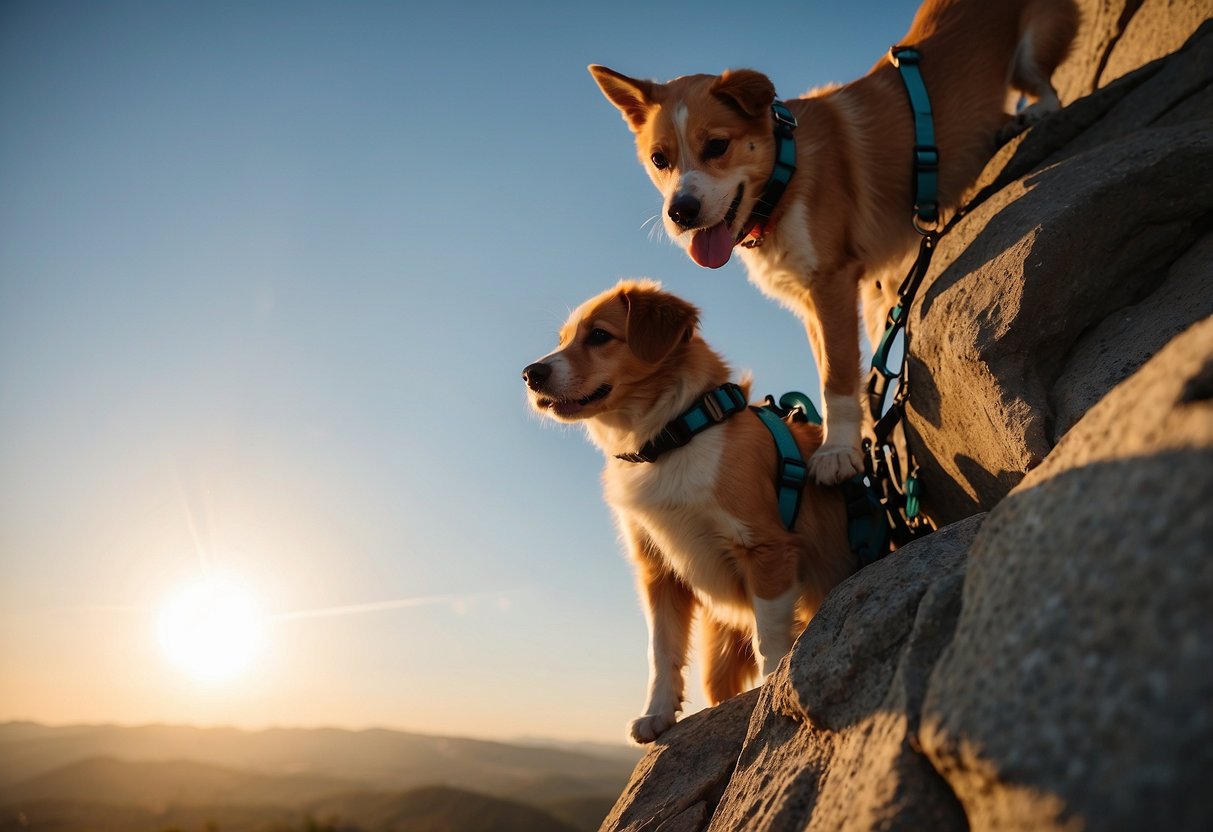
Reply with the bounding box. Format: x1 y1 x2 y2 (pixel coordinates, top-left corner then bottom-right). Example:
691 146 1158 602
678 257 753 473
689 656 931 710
523 280 856 743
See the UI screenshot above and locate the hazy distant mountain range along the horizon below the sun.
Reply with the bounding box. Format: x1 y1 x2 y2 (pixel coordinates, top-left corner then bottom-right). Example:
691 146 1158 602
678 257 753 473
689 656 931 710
0 723 640 832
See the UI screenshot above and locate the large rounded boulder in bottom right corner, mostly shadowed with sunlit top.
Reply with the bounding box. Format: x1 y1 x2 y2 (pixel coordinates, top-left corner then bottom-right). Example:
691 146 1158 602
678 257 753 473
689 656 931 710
921 318 1213 830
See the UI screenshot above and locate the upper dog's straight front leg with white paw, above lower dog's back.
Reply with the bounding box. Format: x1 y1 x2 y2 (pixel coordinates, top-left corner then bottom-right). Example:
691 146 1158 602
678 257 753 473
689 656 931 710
805 262 864 485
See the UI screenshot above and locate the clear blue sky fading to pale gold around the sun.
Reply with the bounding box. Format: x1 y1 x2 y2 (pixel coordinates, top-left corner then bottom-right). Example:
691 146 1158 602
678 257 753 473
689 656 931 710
0 0 916 740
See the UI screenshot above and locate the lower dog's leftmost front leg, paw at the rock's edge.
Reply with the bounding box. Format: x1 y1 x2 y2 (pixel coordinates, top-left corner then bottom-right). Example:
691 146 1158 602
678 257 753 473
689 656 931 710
627 526 695 743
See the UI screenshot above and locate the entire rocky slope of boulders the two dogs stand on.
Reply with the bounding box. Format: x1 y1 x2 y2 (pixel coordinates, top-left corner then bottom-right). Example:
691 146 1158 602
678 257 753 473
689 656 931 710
603 0 1213 832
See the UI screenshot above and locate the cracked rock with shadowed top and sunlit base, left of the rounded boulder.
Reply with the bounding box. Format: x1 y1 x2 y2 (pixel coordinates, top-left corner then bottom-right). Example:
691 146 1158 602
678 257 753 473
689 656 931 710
707 517 983 832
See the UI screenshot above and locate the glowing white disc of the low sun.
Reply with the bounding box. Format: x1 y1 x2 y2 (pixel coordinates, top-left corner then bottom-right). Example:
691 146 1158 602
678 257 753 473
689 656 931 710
156 576 266 682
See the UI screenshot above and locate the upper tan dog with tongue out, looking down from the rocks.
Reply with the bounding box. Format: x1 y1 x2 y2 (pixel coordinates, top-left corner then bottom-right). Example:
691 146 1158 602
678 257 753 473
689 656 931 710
590 0 1078 483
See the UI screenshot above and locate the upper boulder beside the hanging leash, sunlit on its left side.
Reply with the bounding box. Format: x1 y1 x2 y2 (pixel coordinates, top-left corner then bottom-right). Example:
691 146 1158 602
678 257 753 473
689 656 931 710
909 13 1213 523
